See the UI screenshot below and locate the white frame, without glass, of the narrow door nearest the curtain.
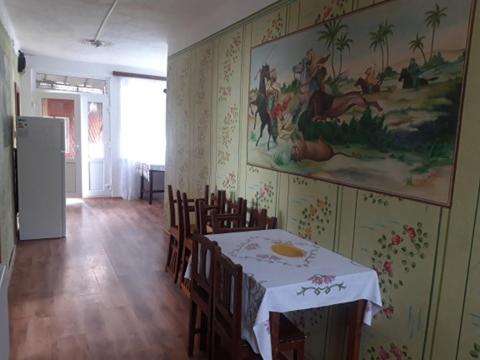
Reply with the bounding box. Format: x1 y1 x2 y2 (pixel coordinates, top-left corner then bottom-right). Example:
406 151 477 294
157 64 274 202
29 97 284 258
81 94 112 197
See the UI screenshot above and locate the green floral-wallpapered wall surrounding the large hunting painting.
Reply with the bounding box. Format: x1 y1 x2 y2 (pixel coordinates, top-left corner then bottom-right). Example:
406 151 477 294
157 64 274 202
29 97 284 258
167 0 480 360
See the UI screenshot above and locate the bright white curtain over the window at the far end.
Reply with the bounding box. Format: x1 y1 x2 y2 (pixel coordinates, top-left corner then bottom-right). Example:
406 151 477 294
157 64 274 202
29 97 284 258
120 78 166 200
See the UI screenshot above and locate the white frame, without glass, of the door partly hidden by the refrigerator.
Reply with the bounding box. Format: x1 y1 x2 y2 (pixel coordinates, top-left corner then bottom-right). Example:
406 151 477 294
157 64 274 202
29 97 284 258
32 90 83 198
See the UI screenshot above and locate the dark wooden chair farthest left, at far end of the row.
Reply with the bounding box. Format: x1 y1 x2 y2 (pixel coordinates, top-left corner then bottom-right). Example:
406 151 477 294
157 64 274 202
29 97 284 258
165 185 182 282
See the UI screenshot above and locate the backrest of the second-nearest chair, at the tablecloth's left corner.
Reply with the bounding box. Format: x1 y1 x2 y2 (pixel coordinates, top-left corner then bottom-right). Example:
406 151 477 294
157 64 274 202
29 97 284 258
190 234 220 307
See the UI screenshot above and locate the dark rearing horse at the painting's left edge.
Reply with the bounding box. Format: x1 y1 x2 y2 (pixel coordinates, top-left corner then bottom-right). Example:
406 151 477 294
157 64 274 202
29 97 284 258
250 64 277 150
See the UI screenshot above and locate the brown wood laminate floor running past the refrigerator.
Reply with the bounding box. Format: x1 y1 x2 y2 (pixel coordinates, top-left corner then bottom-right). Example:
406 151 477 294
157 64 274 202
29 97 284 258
9 199 201 360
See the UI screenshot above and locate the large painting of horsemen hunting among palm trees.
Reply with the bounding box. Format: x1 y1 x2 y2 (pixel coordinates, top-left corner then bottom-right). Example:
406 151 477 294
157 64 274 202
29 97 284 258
247 0 475 207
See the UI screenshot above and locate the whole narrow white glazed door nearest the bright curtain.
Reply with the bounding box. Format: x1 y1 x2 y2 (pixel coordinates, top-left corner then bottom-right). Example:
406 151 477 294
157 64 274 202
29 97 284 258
82 95 112 197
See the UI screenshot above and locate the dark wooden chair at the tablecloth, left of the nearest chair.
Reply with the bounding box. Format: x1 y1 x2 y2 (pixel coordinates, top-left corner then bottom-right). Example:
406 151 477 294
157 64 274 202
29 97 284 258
188 234 220 358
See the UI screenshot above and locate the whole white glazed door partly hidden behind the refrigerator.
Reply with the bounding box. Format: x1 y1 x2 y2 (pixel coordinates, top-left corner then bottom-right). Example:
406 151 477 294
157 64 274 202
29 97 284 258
34 91 82 198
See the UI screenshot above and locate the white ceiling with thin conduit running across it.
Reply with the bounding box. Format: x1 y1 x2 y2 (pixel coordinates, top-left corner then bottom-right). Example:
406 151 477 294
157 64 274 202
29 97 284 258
0 0 275 74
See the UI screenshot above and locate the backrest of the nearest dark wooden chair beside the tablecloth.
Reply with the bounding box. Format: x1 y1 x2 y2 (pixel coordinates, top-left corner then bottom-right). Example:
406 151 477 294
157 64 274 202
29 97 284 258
213 252 243 354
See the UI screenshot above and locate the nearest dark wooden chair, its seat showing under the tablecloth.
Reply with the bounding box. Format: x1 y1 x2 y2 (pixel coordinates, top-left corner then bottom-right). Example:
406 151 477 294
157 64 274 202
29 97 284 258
211 249 305 360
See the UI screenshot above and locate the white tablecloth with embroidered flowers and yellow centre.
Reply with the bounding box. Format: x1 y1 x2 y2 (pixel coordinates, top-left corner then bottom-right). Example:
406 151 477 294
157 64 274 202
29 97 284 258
208 230 382 360
